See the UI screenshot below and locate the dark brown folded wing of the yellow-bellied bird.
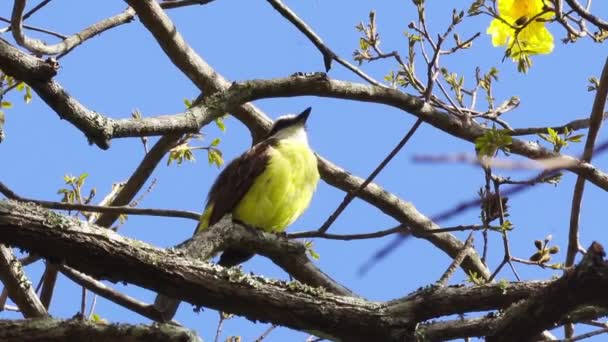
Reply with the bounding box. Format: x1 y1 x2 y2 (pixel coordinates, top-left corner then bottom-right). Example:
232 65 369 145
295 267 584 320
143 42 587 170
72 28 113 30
207 140 272 225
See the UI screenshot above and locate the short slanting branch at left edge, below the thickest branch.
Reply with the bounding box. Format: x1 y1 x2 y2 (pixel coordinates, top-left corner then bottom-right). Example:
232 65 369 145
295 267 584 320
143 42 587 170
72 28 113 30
0 245 48 318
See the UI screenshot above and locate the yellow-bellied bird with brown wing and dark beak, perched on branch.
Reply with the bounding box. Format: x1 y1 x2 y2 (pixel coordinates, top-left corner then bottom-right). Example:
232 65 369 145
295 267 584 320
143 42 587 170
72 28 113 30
154 107 319 321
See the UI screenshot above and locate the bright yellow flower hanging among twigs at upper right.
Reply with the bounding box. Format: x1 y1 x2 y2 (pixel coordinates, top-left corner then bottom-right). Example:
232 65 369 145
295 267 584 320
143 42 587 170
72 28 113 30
486 0 553 61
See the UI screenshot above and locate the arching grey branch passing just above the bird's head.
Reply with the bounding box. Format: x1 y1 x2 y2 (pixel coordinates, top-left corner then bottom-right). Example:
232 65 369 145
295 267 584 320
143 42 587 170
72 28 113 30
17 75 608 200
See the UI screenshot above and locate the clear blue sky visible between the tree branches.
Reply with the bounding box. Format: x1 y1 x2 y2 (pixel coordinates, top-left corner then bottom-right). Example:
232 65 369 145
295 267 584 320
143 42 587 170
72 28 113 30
0 0 608 341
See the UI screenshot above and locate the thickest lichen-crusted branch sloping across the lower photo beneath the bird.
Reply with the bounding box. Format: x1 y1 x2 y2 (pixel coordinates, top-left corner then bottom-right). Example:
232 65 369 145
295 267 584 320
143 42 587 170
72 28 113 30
0 201 592 341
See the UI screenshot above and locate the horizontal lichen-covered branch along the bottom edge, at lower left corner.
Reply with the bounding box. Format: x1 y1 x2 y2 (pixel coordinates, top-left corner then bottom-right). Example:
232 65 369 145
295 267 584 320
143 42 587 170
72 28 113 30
0 318 201 342
